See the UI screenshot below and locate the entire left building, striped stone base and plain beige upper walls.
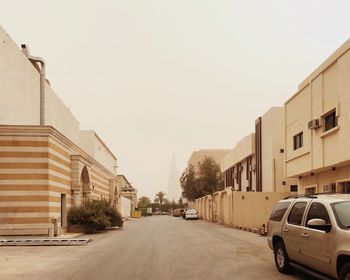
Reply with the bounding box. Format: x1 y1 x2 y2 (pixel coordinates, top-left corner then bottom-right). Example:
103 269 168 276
0 26 118 235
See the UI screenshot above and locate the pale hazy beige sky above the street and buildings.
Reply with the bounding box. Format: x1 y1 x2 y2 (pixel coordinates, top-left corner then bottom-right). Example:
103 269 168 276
0 0 350 198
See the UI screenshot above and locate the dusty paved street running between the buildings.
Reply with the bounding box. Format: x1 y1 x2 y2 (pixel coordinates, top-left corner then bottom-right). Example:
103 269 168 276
0 216 312 280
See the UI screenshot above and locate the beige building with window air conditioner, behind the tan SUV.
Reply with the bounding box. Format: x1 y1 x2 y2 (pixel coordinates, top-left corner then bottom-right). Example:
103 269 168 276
285 37 350 194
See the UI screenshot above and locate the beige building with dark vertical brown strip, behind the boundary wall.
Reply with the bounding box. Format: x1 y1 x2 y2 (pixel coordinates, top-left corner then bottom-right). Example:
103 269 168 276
221 107 297 192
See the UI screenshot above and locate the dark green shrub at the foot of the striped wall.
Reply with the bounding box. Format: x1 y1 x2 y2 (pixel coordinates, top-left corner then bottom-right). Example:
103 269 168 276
68 200 123 233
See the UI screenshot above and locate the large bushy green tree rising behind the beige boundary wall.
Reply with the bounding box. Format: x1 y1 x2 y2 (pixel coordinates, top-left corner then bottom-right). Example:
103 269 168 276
180 157 224 200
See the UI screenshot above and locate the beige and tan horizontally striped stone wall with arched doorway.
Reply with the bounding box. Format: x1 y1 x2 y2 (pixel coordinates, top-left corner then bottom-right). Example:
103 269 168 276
0 126 117 235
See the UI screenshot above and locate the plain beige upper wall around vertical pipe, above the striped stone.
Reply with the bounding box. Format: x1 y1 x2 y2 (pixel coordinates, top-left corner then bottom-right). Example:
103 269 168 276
0 26 79 144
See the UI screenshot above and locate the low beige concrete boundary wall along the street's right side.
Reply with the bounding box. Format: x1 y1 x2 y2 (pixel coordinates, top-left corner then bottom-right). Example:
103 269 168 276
196 189 290 230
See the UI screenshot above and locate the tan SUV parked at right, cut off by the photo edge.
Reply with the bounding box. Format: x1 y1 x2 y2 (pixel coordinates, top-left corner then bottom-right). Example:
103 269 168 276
267 194 350 279
